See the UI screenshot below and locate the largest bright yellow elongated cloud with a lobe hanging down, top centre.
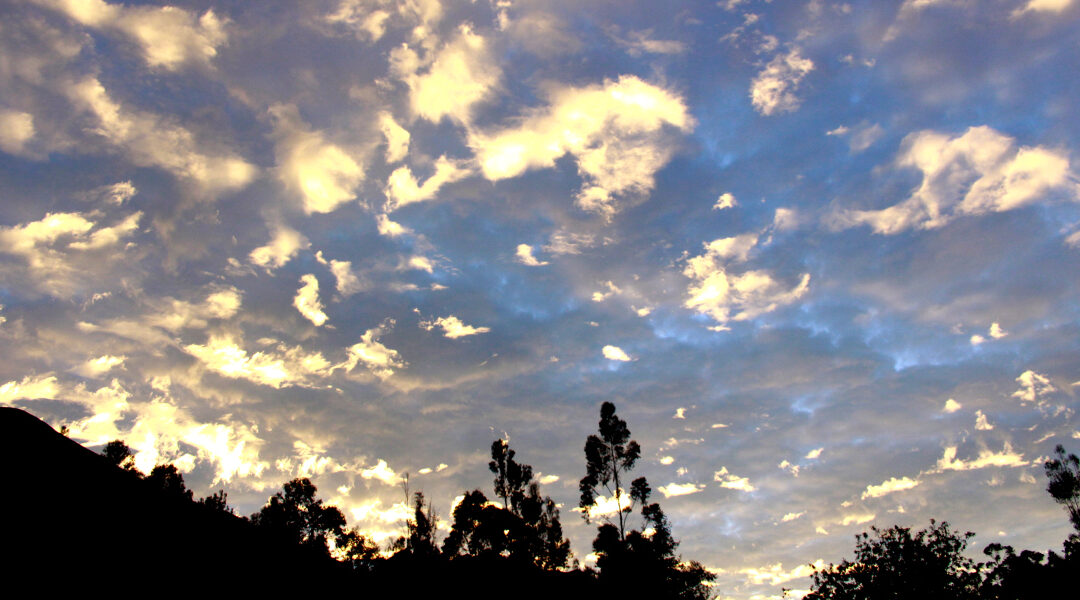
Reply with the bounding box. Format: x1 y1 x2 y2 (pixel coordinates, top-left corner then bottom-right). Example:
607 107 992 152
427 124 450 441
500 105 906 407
469 76 693 218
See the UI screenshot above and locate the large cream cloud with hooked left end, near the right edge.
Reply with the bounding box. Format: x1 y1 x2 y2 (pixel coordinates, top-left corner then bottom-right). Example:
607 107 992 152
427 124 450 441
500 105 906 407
836 125 1078 235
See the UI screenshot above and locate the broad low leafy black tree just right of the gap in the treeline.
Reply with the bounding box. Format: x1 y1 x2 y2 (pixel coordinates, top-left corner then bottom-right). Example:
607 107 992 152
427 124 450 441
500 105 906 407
806 520 982 600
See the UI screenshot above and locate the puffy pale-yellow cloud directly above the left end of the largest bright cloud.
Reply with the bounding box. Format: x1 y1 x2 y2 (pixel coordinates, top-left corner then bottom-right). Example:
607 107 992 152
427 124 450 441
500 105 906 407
391 26 502 123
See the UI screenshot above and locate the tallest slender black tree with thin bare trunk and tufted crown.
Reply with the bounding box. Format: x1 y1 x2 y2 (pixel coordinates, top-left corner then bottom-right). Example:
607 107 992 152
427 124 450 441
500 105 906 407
578 403 642 541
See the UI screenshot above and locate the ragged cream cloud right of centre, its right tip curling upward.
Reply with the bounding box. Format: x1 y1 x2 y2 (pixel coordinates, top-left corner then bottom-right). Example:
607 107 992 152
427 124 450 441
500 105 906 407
683 233 810 326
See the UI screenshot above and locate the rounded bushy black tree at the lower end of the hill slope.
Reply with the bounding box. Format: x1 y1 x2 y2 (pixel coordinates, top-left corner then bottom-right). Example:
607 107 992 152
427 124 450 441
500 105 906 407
252 477 345 554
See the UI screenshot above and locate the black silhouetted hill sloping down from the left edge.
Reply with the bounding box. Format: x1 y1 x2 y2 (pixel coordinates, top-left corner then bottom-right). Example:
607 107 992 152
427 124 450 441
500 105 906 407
0 408 351 594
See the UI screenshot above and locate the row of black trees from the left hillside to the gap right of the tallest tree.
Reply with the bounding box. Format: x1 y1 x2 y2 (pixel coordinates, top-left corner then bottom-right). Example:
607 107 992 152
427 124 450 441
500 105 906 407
103 403 716 600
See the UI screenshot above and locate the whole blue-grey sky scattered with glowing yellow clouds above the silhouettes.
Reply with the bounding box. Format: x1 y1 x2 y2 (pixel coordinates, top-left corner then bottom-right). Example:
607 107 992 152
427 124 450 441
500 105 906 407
0 0 1080 600
